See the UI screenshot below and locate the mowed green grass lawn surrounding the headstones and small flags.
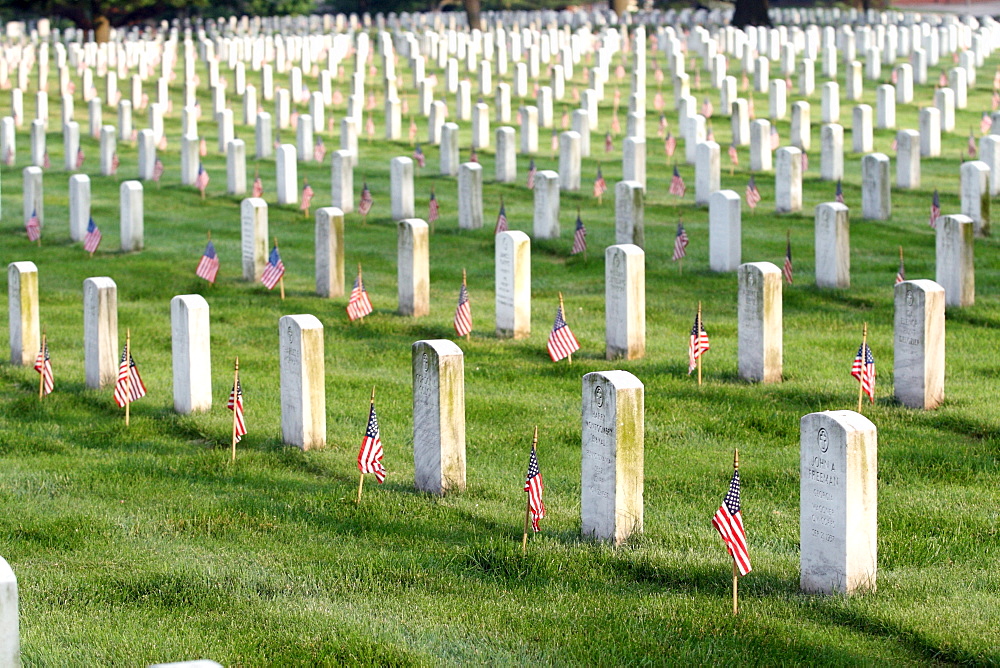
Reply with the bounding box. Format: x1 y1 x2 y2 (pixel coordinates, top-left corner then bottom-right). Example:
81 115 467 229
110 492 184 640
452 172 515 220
0 35 1000 665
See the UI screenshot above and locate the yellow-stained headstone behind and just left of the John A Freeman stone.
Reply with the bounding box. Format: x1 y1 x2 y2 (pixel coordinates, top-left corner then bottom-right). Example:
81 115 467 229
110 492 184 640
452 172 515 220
736 262 782 383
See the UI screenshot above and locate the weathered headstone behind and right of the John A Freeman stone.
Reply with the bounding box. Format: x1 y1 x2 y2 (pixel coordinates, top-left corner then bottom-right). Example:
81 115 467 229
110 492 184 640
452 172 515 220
893 279 945 409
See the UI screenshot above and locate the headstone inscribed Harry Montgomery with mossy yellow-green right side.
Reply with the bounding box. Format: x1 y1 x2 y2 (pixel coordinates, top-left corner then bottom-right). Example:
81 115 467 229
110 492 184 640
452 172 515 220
580 371 645 545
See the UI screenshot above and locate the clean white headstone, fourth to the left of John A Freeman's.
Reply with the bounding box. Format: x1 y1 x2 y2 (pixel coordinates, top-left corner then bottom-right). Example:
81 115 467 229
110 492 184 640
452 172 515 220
170 295 212 415
